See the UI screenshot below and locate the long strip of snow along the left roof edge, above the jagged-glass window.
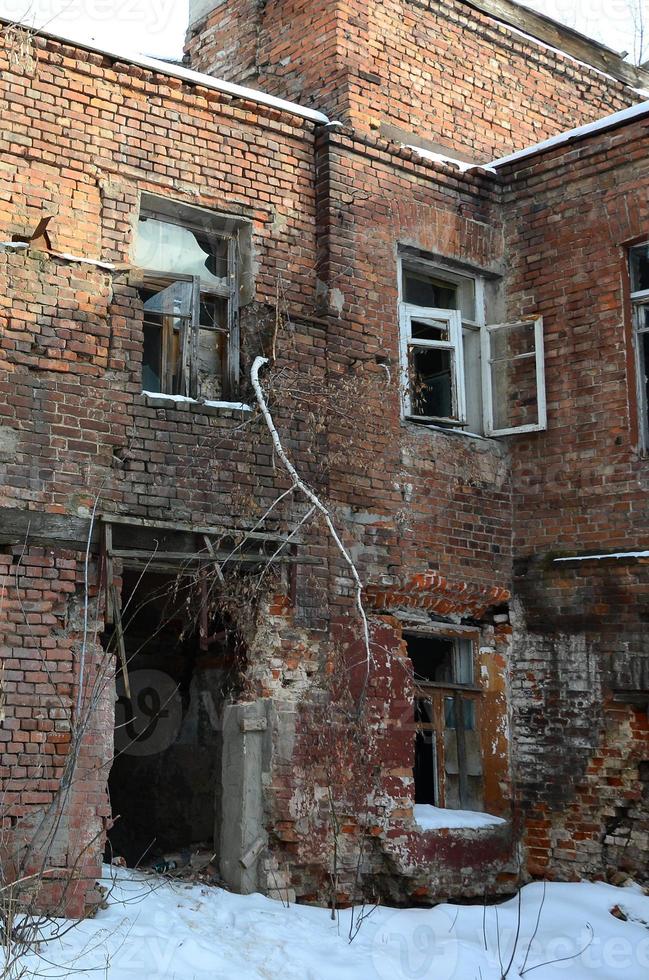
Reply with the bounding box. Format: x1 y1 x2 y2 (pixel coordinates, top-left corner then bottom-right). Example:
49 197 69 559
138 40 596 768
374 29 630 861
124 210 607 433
0 17 329 124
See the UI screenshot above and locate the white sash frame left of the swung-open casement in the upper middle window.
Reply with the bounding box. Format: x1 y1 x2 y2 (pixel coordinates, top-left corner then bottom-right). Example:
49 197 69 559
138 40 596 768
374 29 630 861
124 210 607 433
399 303 466 426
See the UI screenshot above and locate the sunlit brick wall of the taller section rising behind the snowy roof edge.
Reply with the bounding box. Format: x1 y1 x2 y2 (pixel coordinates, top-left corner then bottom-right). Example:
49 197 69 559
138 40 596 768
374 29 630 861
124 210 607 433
187 0 638 161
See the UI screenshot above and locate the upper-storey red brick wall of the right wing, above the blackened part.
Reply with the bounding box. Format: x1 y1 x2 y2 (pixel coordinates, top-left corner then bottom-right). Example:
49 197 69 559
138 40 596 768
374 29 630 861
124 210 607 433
504 118 649 557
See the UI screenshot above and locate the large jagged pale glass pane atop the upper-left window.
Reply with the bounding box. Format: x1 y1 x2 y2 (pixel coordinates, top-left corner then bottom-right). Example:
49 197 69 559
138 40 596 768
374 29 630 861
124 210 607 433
135 218 227 287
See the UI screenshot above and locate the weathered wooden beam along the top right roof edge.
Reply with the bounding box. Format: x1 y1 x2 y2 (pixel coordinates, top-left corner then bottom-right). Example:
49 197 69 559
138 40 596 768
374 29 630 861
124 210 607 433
450 0 649 88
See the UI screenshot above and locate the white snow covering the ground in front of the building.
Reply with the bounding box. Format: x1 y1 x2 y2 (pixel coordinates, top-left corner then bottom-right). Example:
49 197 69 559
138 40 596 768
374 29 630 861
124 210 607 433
13 868 649 980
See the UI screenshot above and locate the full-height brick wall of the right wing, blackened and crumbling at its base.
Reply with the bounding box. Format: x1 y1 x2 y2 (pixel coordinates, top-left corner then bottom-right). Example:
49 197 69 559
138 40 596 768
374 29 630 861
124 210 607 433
504 120 649 875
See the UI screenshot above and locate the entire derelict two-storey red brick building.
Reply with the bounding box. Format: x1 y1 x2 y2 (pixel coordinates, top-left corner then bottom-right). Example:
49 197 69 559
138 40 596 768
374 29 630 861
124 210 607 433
0 0 649 915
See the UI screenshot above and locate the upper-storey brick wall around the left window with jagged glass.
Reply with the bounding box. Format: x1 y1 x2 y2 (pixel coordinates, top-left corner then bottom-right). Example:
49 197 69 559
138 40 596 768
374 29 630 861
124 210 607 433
0 32 323 536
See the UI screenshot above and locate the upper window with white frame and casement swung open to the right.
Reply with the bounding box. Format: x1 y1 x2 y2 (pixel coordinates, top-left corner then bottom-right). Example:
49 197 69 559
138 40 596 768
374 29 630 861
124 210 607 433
400 254 547 435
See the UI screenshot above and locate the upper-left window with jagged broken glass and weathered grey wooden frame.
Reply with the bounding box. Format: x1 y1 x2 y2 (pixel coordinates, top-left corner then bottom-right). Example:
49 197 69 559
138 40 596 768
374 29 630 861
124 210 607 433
135 195 246 400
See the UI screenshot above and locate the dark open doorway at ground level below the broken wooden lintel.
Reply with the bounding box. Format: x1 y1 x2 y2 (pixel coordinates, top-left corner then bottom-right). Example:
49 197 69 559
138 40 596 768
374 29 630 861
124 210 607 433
107 572 239 866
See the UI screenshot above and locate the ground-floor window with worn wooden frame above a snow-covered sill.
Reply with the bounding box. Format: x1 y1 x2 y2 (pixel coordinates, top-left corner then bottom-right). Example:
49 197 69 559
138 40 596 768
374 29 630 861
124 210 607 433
405 634 483 810
